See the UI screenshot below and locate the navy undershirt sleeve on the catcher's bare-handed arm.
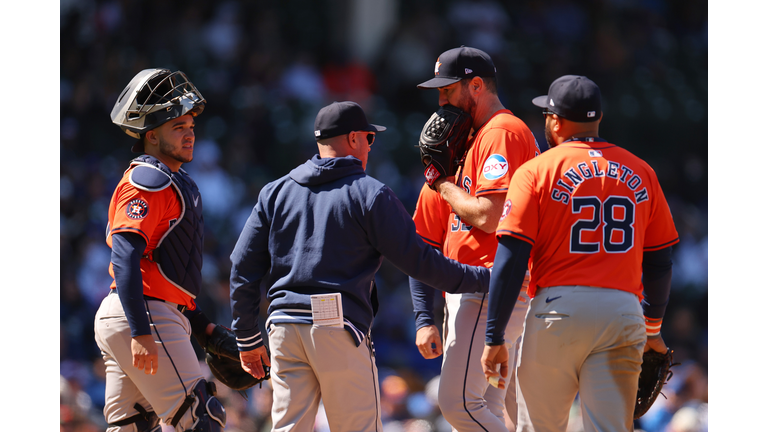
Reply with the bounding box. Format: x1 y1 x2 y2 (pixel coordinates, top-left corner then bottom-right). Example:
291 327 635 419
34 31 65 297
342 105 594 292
112 232 152 337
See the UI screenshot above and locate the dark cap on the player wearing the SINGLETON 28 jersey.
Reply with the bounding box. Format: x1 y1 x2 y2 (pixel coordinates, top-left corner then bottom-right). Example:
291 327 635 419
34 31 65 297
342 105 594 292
533 75 603 123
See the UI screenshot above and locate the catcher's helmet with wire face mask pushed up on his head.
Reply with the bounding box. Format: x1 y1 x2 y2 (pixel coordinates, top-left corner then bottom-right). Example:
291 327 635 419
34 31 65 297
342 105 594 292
110 69 205 153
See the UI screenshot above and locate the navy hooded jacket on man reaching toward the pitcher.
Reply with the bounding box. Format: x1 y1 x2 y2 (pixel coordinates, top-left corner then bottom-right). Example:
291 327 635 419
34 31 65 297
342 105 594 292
230 155 490 351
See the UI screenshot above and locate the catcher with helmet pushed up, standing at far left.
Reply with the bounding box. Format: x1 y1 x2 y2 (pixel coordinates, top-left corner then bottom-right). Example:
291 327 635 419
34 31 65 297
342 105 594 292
94 68 266 432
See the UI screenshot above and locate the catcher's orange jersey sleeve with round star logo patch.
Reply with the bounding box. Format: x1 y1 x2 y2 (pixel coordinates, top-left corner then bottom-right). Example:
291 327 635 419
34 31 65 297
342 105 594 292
109 183 176 244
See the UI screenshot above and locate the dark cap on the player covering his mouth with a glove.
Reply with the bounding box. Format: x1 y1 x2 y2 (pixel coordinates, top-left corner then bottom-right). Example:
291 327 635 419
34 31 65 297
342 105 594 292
416 45 496 88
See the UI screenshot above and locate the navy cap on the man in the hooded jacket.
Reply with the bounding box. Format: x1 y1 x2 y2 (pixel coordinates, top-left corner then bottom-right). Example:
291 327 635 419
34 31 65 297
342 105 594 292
315 101 387 140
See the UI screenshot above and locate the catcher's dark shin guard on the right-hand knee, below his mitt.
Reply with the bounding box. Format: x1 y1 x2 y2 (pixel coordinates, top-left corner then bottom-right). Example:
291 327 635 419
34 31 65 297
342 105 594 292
171 379 227 432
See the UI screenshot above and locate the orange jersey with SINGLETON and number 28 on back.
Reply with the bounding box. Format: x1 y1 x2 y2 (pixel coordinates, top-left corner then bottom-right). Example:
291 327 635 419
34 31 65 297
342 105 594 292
496 138 678 297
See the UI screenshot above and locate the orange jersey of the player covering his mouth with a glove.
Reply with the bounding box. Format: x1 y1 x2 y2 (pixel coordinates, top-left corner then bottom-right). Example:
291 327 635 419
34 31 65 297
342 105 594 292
413 110 539 267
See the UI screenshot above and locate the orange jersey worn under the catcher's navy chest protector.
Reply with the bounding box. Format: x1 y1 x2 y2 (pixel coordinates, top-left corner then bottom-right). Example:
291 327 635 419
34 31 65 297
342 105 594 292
107 167 195 309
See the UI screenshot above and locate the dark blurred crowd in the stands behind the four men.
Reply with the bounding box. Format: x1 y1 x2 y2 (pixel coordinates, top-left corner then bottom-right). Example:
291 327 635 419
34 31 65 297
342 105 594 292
60 0 708 432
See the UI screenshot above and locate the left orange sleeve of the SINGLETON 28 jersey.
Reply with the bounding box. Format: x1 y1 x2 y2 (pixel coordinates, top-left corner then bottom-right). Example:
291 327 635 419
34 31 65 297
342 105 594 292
496 166 539 245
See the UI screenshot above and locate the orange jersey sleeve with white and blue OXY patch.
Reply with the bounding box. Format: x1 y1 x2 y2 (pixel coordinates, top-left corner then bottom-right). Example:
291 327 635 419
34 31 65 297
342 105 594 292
475 127 535 196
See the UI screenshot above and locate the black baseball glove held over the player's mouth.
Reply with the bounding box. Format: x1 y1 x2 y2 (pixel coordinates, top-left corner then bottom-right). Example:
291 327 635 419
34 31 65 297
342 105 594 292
419 105 472 189
